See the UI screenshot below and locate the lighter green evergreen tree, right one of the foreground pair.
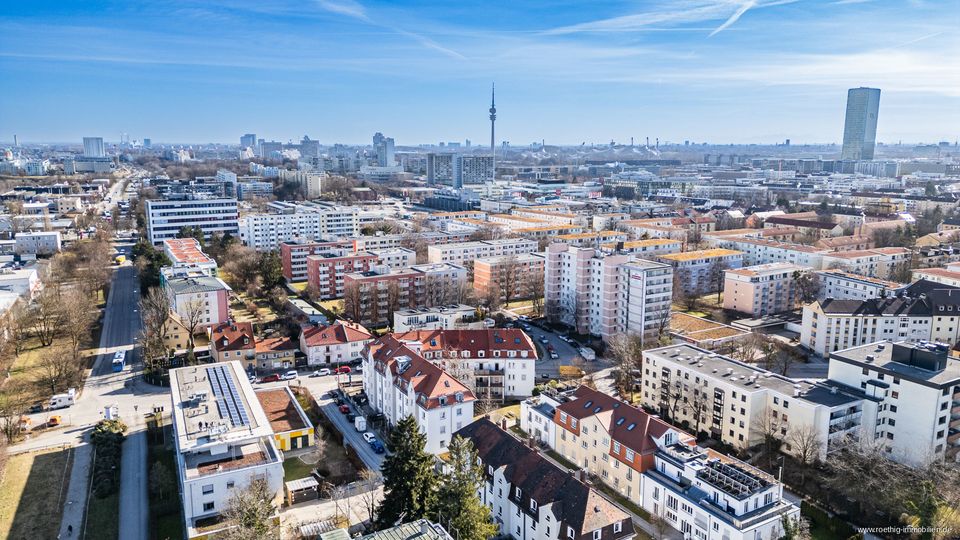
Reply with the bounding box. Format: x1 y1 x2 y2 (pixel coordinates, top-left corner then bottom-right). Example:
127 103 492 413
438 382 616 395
436 437 497 540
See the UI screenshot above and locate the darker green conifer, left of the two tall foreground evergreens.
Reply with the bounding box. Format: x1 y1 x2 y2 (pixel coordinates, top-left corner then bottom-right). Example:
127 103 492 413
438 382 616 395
376 416 437 529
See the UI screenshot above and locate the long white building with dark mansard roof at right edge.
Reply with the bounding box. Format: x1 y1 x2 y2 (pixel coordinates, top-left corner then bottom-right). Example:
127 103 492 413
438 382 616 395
800 289 960 356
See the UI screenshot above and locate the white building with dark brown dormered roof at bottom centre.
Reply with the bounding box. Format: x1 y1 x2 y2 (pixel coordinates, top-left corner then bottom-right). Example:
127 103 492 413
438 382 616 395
457 418 635 540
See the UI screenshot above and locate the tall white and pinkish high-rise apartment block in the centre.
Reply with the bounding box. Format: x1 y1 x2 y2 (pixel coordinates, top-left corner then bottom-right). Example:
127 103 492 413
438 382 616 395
544 243 673 340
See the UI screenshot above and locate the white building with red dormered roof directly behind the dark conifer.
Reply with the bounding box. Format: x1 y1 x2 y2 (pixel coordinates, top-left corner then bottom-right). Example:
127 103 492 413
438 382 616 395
363 335 476 454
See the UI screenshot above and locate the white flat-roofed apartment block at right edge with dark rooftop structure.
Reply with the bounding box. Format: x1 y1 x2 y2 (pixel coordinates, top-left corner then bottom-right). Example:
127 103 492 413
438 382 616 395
828 341 960 466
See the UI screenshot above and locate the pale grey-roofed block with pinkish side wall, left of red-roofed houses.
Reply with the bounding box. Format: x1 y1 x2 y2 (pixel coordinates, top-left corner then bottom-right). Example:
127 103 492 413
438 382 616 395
162 276 232 328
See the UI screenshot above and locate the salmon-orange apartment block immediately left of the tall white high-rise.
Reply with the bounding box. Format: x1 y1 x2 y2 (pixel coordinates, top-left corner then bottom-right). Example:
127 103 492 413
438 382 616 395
473 253 545 301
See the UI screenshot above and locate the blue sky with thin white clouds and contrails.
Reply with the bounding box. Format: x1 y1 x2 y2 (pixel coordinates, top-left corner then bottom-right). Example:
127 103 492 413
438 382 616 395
0 0 960 145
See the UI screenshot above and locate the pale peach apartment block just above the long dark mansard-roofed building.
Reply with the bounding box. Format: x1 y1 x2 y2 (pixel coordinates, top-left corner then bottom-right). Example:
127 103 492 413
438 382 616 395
723 263 810 317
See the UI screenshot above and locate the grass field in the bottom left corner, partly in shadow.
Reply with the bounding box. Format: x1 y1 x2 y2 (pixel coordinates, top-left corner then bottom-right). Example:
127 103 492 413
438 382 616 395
0 448 74 540
